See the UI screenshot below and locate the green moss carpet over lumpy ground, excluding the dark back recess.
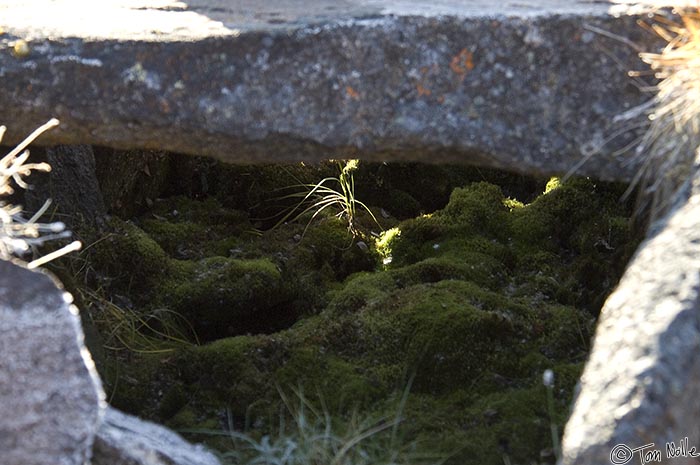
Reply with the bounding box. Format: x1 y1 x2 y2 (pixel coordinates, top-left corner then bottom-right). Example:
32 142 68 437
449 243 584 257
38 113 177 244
74 171 634 465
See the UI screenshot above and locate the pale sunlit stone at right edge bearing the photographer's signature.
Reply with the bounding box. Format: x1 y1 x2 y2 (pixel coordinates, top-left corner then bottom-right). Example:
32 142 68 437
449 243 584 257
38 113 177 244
563 158 700 465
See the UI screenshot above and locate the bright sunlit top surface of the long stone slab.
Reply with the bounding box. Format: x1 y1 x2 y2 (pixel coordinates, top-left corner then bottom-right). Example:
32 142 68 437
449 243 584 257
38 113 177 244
0 0 610 41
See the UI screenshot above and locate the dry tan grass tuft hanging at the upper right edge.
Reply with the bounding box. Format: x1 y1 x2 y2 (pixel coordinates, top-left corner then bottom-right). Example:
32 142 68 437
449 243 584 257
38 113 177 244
620 2 700 220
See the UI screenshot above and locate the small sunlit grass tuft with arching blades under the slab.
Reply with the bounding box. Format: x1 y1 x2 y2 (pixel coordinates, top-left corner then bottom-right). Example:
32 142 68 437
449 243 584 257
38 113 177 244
274 160 381 238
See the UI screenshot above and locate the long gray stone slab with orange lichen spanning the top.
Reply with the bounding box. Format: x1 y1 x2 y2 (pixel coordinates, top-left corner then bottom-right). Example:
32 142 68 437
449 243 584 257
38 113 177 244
0 0 654 180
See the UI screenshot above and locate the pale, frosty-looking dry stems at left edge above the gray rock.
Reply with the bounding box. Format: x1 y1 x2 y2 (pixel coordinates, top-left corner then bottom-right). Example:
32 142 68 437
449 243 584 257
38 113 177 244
0 118 81 268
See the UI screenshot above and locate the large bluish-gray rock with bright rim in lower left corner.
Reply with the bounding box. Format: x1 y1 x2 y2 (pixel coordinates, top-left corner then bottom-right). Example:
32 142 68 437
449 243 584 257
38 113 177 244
0 261 103 465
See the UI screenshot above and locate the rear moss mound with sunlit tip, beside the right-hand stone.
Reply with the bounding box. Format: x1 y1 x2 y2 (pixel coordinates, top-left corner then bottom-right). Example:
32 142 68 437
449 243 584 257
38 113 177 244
510 179 641 314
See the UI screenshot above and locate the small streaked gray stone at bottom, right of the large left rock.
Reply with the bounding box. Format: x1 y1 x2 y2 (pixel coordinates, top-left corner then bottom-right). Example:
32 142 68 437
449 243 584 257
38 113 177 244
92 408 220 465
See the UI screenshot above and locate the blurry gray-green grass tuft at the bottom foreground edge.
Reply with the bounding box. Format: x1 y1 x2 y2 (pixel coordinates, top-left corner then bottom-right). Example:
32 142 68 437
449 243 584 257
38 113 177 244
189 387 450 465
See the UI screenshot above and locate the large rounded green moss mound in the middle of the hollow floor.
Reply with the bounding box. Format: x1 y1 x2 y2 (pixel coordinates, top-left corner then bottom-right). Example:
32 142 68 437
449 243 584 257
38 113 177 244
352 280 515 393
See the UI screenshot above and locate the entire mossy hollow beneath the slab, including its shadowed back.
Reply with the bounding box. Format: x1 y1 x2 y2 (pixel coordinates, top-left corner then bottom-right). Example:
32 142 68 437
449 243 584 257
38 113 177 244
54 161 638 465
